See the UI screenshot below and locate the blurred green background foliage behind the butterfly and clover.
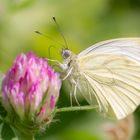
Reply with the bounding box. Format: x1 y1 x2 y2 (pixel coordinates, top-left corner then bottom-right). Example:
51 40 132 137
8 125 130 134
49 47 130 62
0 0 140 140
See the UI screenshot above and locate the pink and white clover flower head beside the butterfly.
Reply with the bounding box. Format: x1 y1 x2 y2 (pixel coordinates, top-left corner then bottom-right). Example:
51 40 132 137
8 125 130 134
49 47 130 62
2 52 61 133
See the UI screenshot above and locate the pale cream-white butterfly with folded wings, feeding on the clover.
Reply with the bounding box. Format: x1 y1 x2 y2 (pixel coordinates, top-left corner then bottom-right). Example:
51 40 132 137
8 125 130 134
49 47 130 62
60 38 140 119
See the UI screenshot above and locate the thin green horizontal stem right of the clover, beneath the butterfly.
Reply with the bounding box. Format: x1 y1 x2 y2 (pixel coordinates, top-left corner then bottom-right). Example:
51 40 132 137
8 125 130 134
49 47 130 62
56 106 98 113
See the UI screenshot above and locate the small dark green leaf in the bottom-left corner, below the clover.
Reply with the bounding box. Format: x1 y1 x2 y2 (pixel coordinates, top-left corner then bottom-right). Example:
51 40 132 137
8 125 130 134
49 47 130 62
1 123 15 140
